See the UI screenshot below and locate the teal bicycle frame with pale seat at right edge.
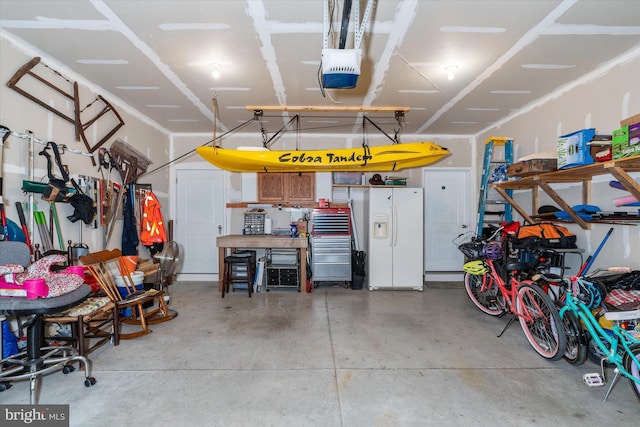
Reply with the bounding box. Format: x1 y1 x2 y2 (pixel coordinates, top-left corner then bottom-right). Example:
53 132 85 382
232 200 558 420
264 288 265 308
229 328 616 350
556 276 640 401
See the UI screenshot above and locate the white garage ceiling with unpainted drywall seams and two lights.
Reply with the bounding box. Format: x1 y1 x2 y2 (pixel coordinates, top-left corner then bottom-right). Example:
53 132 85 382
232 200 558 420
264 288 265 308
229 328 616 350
0 0 640 140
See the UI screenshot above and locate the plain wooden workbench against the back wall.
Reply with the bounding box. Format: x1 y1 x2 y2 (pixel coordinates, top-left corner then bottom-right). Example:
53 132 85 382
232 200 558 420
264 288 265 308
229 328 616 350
216 234 308 291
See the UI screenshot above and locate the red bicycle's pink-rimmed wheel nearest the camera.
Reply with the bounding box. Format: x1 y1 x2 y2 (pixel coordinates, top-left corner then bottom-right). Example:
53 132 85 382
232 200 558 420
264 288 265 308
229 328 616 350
516 281 567 360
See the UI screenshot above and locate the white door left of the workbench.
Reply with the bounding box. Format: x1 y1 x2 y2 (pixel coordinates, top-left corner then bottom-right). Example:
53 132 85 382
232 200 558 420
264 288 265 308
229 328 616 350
175 169 225 280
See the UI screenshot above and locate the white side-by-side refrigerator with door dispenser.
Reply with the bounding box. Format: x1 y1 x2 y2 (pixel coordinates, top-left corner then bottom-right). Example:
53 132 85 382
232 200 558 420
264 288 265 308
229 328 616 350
367 187 424 291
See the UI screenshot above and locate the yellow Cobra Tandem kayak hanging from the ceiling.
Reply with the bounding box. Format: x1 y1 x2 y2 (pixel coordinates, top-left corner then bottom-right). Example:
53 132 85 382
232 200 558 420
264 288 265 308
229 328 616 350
196 142 449 172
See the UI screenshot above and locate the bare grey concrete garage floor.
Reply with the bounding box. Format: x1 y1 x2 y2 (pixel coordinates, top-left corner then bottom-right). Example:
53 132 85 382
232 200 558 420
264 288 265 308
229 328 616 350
0 282 640 427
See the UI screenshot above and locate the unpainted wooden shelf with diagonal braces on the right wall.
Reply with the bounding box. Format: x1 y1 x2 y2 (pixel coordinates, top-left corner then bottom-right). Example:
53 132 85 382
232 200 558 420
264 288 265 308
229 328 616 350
491 156 640 229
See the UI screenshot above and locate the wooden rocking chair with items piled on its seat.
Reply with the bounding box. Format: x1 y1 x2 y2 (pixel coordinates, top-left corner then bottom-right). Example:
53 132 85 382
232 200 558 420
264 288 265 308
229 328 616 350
79 249 178 339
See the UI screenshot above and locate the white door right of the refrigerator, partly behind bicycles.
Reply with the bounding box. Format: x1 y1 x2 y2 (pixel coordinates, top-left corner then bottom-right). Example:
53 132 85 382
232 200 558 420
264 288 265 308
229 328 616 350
423 168 473 275
